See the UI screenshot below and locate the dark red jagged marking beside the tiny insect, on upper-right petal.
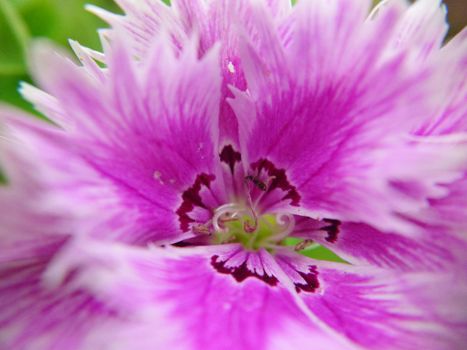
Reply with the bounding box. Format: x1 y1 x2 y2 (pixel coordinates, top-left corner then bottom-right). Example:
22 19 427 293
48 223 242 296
251 159 301 206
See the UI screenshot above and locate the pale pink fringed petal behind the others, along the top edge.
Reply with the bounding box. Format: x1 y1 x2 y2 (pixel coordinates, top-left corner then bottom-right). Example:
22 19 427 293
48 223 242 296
100 0 292 60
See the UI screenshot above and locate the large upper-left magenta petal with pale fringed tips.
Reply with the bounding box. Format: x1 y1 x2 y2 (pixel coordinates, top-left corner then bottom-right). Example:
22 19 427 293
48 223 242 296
16 32 224 242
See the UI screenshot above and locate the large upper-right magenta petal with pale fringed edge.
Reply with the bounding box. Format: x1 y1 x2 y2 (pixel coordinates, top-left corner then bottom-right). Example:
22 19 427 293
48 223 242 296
232 0 466 232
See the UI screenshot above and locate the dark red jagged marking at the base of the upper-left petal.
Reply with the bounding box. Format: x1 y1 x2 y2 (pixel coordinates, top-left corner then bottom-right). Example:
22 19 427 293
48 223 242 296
176 174 216 232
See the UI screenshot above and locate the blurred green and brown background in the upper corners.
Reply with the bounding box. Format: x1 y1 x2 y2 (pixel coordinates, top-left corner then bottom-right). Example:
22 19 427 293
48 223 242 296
0 0 467 110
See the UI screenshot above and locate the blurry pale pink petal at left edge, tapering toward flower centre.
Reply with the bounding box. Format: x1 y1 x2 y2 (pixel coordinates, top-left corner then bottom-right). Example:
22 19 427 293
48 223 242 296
0 108 185 244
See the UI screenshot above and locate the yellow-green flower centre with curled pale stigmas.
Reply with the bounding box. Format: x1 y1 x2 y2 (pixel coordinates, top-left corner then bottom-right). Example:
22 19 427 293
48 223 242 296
212 204 295 250
